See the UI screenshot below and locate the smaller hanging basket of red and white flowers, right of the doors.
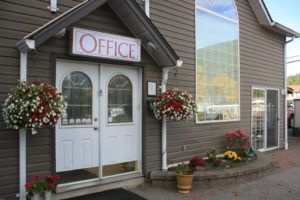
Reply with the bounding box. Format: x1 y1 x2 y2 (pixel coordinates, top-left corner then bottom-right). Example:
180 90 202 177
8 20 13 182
152 88 196 121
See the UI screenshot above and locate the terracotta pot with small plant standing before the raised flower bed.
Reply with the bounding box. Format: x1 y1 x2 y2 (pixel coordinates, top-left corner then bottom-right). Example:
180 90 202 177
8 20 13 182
176 163 195 194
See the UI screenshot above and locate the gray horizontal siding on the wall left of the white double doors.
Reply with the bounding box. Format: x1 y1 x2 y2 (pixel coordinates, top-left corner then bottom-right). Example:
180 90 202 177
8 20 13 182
0 0 84 199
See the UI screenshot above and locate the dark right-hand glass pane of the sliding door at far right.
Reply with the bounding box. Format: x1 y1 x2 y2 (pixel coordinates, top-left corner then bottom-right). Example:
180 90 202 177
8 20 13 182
267 90 278 148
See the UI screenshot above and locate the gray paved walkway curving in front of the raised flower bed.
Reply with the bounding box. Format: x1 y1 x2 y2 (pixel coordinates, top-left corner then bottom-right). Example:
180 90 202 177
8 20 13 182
131 134 300 200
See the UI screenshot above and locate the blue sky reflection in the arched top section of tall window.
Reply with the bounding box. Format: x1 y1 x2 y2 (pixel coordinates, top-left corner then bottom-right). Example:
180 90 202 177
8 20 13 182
196 0 237 20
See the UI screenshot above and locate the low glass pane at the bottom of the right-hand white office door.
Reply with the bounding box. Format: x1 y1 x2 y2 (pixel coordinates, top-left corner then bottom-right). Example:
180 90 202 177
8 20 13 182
102 161 137 176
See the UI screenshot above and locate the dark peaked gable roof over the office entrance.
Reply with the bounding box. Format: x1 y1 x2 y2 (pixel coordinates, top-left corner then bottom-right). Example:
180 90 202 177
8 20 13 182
17 0 179 67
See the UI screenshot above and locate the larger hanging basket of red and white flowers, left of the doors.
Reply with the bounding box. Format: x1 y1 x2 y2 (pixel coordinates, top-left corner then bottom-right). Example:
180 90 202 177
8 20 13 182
2 81 66 134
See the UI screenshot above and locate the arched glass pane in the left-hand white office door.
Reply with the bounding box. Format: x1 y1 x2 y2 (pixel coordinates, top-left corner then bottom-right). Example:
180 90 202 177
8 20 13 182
61 72 92 126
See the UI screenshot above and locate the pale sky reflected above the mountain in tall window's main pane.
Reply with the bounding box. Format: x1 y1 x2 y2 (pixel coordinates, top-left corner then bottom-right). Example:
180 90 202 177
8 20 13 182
196 10 238 49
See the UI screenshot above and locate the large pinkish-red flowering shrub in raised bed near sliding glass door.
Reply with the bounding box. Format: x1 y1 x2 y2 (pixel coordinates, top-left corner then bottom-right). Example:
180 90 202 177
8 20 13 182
225 130 250 157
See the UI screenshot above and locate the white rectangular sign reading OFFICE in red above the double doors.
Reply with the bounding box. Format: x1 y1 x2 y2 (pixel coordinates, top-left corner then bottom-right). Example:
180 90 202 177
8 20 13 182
72 28 141 62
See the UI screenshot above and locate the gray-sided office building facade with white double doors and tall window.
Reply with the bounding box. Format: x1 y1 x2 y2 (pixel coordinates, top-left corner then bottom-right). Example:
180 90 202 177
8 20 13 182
0 0 299 199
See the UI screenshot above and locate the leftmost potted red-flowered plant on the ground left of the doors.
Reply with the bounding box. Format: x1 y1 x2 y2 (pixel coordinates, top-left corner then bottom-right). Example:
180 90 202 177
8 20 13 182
25 175 45 200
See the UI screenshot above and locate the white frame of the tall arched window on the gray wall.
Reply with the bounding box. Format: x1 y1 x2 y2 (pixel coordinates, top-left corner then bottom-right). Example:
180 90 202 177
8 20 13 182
194 0 241 124
